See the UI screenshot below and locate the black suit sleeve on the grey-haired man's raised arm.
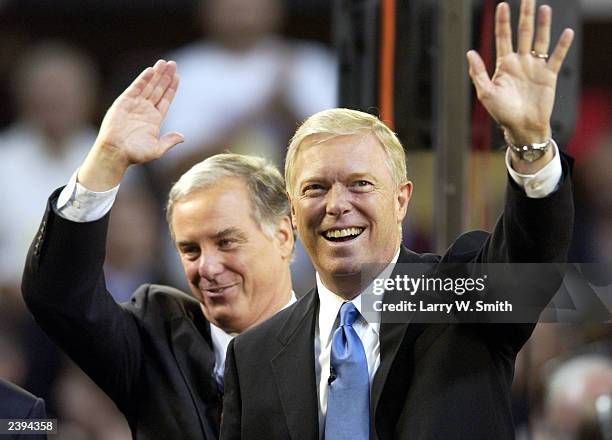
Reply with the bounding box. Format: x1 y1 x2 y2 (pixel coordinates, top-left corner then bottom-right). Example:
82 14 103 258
22 190 141 413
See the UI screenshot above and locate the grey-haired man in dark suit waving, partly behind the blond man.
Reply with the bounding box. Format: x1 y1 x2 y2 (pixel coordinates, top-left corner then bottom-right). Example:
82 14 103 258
22 60 294 440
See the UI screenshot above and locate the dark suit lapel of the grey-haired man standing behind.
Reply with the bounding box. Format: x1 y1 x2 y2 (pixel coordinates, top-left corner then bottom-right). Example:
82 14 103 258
170 309 221 438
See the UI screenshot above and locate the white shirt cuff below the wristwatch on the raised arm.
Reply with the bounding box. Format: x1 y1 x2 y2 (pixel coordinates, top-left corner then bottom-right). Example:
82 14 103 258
506 139 563 199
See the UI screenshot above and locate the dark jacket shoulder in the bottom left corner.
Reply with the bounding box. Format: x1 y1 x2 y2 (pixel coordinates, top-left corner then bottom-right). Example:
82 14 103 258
0 379 47 440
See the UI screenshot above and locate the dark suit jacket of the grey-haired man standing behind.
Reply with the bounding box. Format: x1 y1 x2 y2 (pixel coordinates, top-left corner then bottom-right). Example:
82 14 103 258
22 190 221 440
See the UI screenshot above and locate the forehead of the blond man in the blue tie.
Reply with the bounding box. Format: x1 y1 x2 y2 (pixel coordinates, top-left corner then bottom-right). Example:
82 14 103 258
293 133 391 185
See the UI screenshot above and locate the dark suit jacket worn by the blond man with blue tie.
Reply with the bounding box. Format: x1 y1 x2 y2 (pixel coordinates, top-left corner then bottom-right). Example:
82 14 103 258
221 160 573 440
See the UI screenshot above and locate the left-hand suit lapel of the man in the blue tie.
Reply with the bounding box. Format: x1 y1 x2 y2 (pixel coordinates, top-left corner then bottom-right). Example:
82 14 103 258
271 289 319 440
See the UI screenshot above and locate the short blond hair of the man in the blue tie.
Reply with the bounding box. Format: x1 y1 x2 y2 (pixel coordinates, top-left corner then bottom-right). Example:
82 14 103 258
285 108 408 194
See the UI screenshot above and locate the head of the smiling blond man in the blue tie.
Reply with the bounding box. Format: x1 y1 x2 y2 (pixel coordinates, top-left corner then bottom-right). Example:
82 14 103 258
286 131 412 297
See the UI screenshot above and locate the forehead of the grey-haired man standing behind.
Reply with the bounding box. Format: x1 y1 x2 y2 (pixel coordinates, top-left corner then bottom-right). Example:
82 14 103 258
172 177 259 241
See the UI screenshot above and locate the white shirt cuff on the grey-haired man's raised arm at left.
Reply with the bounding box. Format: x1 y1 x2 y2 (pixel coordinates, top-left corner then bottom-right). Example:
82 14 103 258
56 168 119 223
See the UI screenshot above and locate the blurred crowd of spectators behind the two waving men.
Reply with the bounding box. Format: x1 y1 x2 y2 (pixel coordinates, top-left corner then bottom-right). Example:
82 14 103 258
0 0 612 440
